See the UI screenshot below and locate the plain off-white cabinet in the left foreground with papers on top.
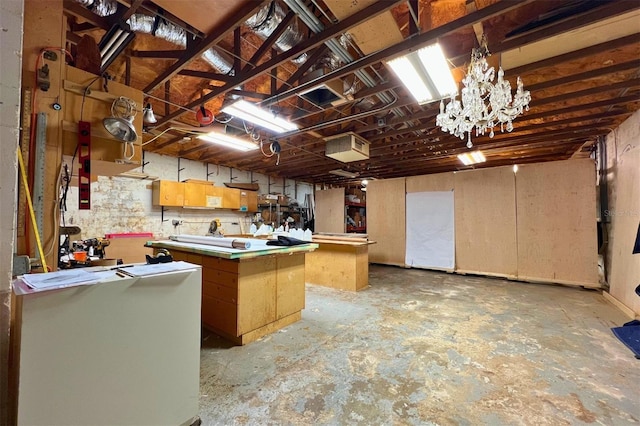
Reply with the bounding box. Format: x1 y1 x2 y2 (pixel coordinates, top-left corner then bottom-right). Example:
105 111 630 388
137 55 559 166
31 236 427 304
14 265 202 426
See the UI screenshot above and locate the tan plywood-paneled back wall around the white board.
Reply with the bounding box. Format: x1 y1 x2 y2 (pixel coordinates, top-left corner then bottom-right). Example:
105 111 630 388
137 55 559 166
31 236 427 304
367 159 600 287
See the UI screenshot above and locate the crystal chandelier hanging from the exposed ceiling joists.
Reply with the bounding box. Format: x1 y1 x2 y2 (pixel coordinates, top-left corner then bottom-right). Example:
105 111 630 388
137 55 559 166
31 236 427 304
436 36 531 148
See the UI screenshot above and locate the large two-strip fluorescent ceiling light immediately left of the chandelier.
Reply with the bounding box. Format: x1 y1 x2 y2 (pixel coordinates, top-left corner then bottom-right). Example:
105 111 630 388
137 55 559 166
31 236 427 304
387 43 458 105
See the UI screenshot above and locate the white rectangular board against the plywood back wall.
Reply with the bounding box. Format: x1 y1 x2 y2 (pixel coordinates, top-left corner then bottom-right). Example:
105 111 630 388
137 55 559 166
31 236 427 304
405 191 455 270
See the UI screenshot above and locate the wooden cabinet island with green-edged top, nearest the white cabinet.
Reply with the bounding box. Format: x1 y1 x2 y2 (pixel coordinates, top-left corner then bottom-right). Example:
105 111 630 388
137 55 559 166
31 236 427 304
146 241 318 345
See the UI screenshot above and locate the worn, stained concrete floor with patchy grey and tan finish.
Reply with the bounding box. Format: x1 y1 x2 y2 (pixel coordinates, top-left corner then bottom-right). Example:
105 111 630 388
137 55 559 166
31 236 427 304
200 265 640 425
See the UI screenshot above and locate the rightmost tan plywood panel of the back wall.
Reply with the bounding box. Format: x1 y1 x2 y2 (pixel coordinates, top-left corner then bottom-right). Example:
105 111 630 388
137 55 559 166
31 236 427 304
516 159 599 287
